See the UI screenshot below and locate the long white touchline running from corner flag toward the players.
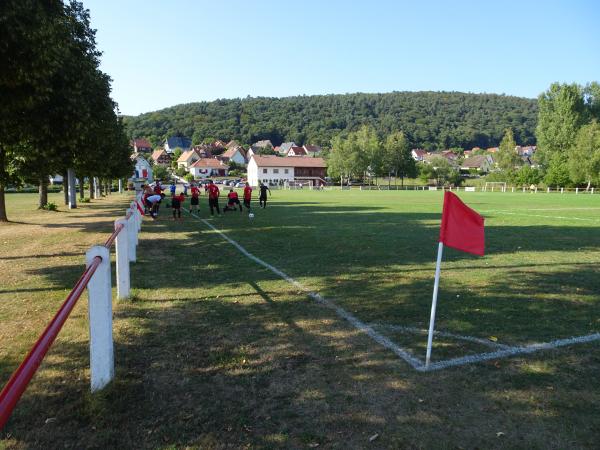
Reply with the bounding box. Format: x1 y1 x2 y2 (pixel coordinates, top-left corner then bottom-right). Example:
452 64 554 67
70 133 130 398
191 214 424 369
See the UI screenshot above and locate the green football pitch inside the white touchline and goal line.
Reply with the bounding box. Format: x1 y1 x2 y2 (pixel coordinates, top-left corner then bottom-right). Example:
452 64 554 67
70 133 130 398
200 191 600 370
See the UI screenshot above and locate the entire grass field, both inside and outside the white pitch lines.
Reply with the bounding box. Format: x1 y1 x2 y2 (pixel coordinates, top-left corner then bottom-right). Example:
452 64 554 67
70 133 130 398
0 191 600 449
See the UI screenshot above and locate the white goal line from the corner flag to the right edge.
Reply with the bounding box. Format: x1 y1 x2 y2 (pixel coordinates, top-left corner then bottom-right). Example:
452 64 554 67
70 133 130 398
415 333 600 372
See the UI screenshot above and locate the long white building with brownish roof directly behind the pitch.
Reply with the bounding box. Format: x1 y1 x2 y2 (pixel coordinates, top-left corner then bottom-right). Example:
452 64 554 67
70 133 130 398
248 155 327 186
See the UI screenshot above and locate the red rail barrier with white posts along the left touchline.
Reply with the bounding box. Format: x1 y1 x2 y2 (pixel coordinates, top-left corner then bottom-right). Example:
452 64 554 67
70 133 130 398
0 192 144 429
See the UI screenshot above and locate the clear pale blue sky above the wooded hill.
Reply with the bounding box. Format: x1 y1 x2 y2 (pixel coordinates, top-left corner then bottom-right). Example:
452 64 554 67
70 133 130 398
82 0 600 115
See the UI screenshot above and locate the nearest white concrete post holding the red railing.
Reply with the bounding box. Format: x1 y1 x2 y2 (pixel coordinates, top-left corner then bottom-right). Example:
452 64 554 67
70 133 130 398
85 245 115 392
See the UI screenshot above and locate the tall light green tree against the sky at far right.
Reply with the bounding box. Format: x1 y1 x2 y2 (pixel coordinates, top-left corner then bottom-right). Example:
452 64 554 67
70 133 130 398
535 83 585 166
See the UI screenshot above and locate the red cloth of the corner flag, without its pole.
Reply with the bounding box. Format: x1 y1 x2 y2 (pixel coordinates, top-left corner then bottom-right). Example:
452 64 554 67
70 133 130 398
440 192 485 256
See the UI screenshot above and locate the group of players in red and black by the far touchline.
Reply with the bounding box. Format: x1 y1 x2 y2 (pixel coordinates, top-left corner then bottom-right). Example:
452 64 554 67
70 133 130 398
143 180 271 220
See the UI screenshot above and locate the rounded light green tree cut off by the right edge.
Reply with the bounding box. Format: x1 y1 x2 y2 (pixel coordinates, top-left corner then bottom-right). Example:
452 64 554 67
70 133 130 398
568 120 600 189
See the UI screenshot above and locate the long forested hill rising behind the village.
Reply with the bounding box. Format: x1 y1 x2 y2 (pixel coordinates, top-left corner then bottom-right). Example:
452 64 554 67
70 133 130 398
125 92 537 150
